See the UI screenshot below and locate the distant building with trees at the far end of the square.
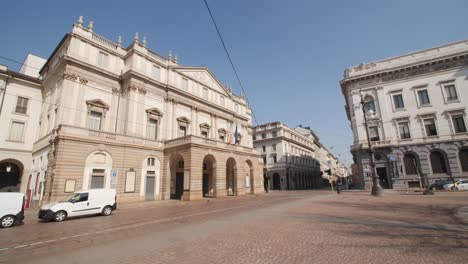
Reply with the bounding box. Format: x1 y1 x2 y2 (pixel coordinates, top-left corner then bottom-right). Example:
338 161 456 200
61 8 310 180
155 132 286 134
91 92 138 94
253 122 338 190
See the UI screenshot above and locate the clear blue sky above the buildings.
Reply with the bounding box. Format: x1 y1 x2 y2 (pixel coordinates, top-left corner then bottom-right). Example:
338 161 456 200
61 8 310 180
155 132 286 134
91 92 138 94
0 0 468 165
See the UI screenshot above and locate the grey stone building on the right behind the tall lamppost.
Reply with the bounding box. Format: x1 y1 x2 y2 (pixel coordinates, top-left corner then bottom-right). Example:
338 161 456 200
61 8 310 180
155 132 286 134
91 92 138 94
341 40 468 189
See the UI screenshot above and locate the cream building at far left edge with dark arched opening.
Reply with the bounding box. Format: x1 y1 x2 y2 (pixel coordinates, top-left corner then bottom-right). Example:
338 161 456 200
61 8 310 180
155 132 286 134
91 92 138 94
0 58 43 205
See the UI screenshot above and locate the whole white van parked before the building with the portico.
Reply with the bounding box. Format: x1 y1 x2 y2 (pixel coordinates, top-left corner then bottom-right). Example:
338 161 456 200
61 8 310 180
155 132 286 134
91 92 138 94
39 189 117 222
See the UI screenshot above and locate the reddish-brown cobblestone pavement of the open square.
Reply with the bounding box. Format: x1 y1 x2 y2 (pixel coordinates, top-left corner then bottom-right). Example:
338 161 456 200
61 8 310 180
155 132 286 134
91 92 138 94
0 191 468 264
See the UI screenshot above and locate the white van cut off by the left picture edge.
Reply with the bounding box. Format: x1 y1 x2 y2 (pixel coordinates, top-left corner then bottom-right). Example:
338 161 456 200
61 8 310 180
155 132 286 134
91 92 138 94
0 192 25 227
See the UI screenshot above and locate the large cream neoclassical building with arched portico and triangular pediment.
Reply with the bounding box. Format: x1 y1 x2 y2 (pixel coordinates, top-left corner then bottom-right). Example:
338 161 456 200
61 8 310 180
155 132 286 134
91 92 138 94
33 17 263 201
